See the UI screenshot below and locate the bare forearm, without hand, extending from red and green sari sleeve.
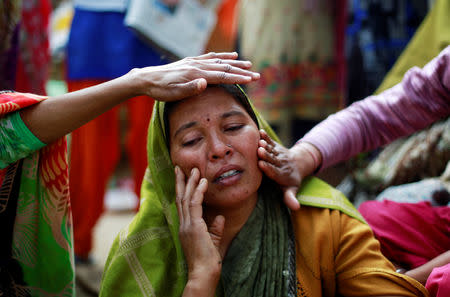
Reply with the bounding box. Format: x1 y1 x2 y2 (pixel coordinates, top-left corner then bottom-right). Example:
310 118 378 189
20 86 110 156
20 74 138 143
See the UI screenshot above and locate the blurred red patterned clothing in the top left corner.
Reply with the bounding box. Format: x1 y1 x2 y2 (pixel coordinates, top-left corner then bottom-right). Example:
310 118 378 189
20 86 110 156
0 0 52 95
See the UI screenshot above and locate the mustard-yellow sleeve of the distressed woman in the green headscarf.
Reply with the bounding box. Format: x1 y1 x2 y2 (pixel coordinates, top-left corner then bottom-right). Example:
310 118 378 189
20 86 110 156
335 213 428 296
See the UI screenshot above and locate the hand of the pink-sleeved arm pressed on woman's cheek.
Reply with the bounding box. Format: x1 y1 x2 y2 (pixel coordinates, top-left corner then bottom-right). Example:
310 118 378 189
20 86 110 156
258 130 302 210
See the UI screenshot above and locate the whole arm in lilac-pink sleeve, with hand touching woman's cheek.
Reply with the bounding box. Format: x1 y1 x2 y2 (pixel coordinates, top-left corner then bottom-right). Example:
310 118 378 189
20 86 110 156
258 46 450 210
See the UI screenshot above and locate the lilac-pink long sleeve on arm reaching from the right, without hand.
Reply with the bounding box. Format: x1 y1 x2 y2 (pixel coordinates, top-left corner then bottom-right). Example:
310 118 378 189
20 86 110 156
301 46 450 169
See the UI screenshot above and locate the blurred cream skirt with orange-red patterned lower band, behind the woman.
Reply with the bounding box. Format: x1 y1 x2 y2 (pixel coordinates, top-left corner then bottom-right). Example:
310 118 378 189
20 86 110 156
239 0 346 142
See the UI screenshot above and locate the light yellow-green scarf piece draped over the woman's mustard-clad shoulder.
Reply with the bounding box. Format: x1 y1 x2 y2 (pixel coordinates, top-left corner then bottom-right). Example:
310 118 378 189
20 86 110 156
297 177 365 223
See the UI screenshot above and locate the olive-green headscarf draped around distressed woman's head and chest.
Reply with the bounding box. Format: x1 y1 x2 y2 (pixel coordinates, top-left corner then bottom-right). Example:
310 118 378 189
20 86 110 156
100 84 361 297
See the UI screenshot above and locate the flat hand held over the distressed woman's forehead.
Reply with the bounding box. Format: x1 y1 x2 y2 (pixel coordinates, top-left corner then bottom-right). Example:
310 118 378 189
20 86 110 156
130 53 260 101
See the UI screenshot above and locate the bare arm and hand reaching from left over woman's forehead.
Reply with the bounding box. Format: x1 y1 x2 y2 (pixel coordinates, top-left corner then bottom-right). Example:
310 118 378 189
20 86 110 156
20 53 259 143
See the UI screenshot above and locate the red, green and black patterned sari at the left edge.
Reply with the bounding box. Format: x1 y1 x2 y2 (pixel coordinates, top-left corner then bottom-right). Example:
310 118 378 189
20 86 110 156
0 92 74 297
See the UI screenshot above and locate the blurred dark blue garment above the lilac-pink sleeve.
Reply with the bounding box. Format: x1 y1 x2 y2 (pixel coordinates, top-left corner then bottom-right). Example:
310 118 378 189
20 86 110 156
346 0 428 105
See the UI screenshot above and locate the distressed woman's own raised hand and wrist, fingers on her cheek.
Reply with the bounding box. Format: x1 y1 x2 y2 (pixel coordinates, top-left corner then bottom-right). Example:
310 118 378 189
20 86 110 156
175 166 225 296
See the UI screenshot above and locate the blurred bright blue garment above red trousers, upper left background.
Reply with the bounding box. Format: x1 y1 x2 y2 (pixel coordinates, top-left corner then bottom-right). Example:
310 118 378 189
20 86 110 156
67 8 170 80
